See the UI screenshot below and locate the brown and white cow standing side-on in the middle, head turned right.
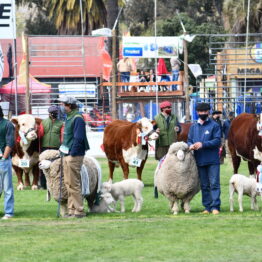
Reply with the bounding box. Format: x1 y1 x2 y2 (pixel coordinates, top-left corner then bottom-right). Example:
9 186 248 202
103 118 158 180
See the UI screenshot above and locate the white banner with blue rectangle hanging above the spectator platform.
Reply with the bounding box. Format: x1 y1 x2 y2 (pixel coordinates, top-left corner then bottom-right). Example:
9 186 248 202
122 36 183 58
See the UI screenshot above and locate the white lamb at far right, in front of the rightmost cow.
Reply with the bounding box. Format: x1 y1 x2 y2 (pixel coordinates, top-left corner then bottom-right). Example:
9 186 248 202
229 174 259 212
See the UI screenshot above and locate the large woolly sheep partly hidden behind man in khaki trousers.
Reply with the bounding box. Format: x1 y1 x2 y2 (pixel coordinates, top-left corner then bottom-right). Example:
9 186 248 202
39 150 102 216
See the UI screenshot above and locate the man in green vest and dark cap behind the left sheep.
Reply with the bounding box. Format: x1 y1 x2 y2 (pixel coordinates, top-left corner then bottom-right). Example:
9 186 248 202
39 105 63 189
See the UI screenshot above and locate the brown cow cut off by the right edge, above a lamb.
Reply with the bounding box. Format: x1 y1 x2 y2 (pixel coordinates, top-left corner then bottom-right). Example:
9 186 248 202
228 113 262 175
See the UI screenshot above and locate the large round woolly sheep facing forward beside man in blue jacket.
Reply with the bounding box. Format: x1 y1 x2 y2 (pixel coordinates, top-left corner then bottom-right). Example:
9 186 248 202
155 142 200 215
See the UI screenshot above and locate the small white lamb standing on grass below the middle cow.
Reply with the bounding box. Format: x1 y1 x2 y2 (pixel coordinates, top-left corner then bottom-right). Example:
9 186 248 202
102 178 144 212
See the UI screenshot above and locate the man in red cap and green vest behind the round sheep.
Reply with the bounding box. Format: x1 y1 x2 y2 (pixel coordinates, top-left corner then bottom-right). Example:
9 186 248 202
154 101 181 160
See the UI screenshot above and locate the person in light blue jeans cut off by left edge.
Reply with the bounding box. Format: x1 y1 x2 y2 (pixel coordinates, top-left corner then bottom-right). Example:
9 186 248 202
0 106 15 220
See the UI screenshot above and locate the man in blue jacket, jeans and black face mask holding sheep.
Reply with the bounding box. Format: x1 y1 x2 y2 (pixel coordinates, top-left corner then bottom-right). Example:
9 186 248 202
187 103 221 215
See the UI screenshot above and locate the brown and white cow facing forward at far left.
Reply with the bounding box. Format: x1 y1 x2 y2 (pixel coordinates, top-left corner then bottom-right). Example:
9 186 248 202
12 114 41 190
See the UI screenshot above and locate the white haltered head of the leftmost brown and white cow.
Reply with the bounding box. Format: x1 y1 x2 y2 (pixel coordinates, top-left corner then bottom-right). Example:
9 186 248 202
12 114 37 141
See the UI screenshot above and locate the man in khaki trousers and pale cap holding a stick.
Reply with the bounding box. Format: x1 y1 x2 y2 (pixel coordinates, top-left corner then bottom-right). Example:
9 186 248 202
59 96 89 218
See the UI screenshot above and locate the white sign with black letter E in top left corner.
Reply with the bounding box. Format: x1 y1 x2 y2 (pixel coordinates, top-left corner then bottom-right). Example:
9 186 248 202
0 0 16 39
